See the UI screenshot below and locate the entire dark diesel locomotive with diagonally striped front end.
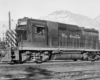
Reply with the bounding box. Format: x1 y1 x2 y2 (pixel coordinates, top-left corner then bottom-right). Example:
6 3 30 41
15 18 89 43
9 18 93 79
1 17 100 63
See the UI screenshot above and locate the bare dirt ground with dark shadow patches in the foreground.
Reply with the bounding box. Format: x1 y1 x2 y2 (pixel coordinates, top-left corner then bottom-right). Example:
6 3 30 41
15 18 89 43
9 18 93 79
0 63 100 80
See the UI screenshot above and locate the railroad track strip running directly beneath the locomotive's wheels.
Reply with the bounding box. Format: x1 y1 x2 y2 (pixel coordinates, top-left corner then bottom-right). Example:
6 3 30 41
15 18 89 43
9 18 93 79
0 60 100 66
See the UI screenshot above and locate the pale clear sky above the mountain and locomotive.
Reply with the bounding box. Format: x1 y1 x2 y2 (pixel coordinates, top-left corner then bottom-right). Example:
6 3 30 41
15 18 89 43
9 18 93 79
0 0 100 21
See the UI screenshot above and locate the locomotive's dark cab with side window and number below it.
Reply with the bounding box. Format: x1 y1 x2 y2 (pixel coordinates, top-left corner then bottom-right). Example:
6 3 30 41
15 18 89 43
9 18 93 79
16 18 48 49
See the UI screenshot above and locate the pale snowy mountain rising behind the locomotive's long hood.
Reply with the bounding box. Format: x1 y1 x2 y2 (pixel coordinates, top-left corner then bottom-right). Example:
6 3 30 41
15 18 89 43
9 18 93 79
40 10 100 37
